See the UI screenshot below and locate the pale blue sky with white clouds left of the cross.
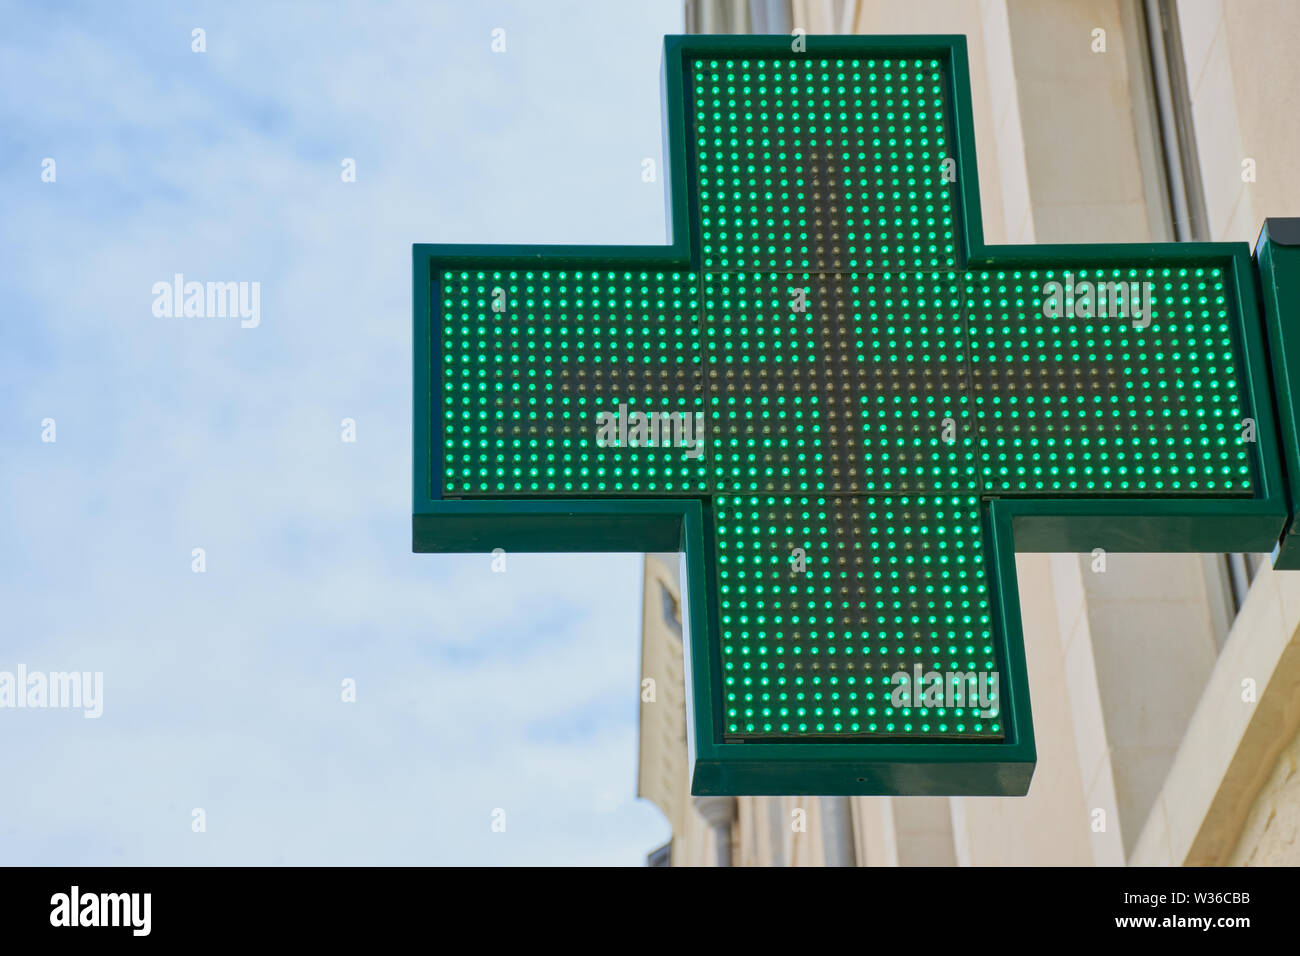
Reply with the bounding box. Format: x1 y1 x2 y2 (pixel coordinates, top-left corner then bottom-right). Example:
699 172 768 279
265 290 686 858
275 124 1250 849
0 0 681 865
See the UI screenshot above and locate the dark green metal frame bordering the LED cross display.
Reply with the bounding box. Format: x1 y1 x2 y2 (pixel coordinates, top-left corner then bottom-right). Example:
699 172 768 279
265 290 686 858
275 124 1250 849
412 36 1300 795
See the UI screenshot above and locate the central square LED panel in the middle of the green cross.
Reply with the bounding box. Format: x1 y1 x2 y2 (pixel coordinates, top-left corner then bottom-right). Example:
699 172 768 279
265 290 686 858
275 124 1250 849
703 272 979 494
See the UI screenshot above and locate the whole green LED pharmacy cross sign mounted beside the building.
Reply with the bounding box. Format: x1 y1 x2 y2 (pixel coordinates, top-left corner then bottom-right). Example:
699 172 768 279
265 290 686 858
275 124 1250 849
413 36 1300 795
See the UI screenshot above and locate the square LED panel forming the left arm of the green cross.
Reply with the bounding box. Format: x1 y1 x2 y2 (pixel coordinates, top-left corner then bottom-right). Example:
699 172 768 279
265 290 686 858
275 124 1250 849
441 271 705 497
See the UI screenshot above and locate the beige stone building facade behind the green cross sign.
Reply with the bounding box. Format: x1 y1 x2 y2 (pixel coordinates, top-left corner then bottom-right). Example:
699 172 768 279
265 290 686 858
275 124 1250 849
638 0 1300 866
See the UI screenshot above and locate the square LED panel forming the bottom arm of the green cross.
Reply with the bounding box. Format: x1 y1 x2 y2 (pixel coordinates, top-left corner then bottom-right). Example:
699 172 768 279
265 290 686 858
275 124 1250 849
716 494 1002 739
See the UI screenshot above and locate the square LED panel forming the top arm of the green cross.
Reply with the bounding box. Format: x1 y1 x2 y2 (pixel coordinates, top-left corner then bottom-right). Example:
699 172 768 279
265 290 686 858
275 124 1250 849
690 56 957 272
